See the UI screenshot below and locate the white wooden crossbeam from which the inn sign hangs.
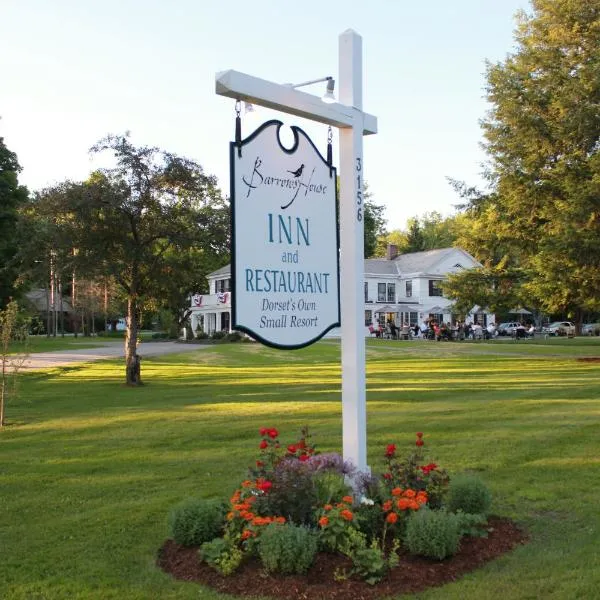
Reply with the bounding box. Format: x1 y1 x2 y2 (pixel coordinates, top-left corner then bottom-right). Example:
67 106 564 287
215 69 377 135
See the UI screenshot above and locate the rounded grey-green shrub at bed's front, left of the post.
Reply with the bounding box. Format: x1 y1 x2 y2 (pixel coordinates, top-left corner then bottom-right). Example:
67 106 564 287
258 523 317 574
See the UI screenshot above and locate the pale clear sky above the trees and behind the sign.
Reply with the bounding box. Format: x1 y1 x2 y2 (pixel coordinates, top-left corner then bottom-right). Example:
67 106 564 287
0 0 530 230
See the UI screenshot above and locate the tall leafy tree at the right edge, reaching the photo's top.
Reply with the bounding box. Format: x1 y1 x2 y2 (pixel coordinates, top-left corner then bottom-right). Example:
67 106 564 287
463 0 600 323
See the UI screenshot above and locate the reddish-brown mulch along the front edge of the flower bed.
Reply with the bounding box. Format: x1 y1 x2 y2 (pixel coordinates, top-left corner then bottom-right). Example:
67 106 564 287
157 517 527 600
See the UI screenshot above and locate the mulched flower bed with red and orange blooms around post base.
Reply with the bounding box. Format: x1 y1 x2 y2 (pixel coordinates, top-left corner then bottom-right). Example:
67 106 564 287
158 427 525 599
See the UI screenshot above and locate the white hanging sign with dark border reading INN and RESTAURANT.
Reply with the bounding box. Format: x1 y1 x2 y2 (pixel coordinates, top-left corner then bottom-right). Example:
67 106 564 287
230 121 340 349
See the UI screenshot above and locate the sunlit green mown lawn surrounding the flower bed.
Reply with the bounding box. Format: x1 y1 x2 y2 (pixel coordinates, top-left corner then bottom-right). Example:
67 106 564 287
0 338 600 600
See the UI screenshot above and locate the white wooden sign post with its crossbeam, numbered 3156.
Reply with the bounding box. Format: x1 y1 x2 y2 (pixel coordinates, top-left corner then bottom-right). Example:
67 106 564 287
216 30 377 471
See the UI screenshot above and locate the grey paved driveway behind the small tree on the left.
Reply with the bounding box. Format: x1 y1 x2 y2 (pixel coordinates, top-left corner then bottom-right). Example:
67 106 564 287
21 342 208 370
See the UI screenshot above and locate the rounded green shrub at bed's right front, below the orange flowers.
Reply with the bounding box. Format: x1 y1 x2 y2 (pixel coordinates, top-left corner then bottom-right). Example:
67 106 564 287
404 508 460 560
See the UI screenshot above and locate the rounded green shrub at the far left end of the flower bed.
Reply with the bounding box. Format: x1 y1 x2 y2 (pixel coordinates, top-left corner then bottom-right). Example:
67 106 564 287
169 498 226 546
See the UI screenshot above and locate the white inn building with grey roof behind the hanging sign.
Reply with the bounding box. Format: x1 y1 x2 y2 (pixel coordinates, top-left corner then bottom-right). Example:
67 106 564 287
191 245 494 336
